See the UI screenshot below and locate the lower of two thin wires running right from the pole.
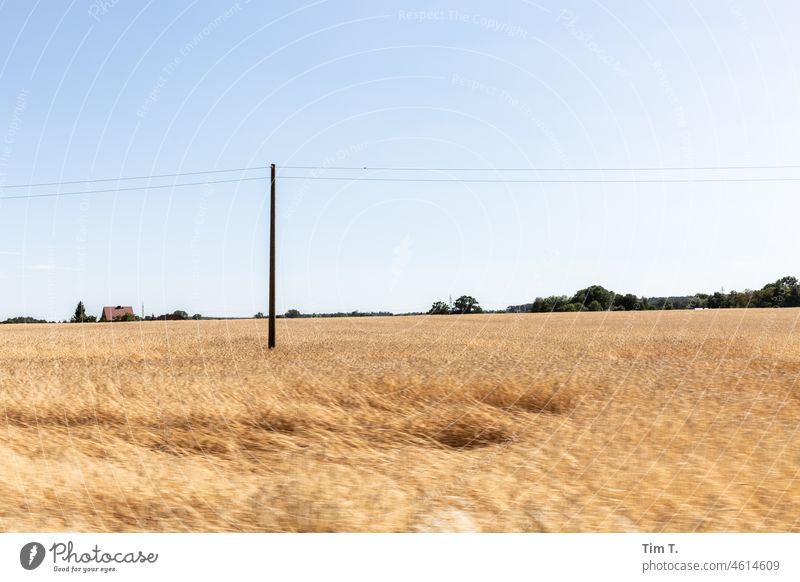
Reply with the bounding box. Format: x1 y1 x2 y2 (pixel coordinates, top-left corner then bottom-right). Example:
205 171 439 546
279 176 800 184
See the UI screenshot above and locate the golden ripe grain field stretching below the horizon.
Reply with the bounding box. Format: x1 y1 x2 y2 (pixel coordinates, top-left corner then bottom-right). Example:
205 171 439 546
0 309 800 531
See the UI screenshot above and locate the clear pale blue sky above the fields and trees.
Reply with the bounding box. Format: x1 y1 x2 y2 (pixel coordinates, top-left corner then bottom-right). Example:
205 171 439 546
0 0 800 319
